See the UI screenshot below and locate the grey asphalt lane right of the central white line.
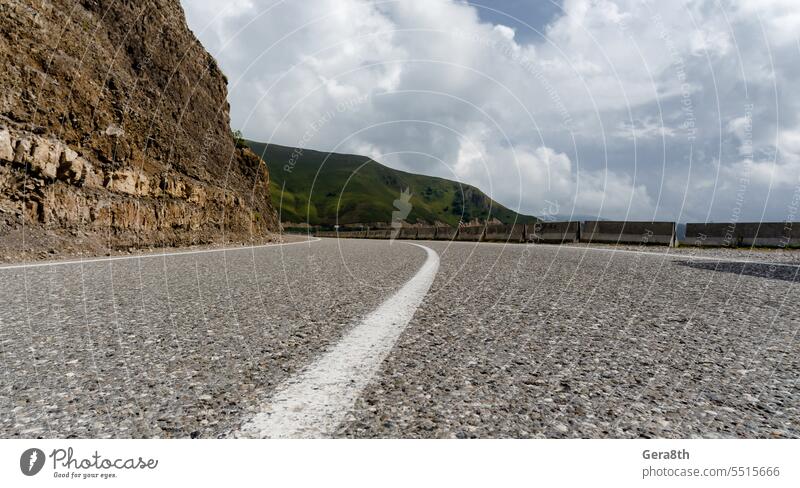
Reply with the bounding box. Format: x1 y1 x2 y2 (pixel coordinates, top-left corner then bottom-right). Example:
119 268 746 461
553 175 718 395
338 243 800 438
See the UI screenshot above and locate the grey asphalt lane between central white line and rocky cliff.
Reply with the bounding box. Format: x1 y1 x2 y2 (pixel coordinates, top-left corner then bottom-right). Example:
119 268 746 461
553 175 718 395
0 240 425 438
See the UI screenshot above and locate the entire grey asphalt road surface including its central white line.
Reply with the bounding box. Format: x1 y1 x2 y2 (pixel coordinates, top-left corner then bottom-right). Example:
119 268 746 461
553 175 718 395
0 239 800 438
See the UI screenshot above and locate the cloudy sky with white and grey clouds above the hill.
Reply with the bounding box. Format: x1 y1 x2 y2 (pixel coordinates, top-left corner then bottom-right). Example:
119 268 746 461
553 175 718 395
183 0 800 222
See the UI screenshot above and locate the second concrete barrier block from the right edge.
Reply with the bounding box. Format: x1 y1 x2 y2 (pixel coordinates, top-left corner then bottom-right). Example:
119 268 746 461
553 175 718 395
579 220 675 246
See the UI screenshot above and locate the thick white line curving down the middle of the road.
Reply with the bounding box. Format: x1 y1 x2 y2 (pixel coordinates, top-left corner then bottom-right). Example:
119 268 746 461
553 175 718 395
236 243 439 438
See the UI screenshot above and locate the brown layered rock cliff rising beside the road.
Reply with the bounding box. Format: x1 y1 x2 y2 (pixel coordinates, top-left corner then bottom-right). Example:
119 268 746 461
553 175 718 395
0 0 279 256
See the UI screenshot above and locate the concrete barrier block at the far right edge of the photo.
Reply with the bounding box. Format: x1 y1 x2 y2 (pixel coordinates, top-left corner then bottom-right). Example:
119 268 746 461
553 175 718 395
681 222 800 247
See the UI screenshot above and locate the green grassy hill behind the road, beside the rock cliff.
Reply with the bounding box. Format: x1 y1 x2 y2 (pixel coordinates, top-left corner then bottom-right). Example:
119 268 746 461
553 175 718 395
246 141 537 225
